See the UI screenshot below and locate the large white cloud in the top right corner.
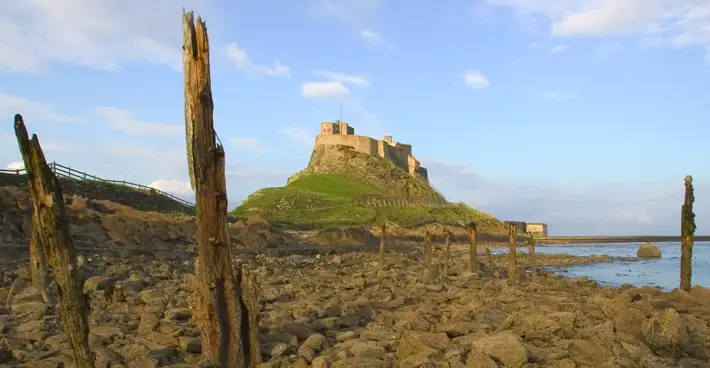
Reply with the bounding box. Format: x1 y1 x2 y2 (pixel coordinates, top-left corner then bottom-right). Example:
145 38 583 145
487 0 710 58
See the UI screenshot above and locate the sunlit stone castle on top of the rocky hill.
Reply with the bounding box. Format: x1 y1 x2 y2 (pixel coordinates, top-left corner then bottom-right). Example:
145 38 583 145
316 120 429 184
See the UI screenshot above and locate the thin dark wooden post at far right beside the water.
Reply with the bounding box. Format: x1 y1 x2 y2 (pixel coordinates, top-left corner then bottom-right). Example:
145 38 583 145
680 175 695 291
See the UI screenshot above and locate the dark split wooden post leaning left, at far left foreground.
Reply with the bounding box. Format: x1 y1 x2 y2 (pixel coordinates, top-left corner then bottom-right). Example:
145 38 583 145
15 114 94 368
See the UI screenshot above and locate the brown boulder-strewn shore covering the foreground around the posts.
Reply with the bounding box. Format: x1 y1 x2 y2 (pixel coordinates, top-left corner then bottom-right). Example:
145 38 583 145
0 246 710 368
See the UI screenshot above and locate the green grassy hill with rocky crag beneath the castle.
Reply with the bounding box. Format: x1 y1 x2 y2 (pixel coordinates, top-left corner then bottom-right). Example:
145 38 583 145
232 147 504 233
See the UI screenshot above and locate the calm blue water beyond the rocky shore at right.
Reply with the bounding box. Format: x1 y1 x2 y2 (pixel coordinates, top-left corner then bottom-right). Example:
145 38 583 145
506 242 710 290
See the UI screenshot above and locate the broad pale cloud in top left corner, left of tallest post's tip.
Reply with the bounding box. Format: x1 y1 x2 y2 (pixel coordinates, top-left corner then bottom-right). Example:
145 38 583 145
0 0 215 73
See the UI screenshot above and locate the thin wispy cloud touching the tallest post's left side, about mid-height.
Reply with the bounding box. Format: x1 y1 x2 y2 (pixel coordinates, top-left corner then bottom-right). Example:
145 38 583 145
95 107 184 137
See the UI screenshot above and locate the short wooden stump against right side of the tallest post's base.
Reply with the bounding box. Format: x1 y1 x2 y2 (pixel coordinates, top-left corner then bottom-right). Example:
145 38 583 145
241 265 263 368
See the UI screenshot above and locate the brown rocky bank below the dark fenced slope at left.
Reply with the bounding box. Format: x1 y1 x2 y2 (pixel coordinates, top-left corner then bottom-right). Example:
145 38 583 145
0 187 298 250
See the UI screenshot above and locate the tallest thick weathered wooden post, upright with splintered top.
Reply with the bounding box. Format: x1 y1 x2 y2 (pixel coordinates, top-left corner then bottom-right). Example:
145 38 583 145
182 12 249 367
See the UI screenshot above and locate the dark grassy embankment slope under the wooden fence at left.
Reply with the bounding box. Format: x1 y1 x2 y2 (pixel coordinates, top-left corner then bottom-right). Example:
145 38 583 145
0 173 195 215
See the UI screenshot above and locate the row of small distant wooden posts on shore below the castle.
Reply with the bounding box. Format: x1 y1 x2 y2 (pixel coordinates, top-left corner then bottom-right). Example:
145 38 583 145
378 222 537 283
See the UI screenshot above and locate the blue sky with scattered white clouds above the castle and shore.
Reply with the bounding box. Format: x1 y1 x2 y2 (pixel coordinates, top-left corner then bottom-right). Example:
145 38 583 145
0 0 710 235
